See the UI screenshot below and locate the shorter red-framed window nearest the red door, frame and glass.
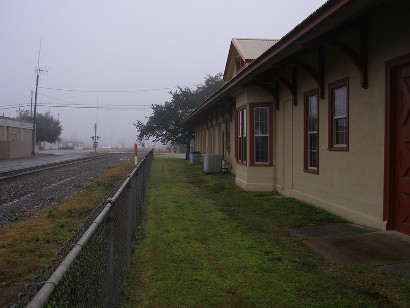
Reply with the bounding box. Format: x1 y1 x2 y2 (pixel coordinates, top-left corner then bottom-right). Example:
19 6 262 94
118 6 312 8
329 79 349 151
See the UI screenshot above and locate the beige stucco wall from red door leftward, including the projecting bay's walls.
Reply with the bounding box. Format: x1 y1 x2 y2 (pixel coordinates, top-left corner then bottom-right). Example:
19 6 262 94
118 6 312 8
192 1 410 229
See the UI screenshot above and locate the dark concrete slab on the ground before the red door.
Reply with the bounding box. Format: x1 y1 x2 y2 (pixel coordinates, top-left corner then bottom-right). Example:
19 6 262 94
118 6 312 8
290 223 410 277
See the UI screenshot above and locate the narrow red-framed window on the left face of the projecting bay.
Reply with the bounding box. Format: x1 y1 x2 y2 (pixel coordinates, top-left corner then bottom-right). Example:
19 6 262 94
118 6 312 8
235 105 248 165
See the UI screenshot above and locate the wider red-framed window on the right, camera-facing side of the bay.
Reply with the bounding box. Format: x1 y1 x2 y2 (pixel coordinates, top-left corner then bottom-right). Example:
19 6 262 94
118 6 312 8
250 104 273 166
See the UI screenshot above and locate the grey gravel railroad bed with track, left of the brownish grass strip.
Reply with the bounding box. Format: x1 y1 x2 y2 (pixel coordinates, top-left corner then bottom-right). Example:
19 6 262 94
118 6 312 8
0 153 132 227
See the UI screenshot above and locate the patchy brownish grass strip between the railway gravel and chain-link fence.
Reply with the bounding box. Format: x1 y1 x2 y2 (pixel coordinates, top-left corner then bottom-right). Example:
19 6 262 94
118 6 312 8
0 161 133 307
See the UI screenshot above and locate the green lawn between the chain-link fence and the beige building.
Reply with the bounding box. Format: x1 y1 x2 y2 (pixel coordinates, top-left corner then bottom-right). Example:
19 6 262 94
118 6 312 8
122 158 410 307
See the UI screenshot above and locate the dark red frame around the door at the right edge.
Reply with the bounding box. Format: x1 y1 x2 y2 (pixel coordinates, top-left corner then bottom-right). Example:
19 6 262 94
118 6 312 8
383 53 410 230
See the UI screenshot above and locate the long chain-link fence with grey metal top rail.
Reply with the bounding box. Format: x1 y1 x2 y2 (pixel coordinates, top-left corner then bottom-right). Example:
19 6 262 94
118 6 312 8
19 151 153 307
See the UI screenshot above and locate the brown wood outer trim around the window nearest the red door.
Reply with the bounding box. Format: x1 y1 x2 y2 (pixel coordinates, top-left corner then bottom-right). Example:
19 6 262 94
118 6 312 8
328 77 350 152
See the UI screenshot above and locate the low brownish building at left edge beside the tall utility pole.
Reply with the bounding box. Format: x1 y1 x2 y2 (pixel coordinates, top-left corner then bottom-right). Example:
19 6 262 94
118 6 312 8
0 117 33 159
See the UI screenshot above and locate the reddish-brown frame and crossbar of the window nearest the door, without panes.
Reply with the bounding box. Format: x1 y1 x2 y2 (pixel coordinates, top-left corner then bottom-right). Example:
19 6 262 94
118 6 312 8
328 78 349 151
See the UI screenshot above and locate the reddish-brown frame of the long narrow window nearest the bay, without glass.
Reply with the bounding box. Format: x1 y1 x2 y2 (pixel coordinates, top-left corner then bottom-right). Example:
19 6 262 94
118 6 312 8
303 88 320 174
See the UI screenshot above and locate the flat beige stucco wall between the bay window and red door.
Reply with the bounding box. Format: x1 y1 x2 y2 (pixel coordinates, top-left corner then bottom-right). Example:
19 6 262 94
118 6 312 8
276 1 410 229
